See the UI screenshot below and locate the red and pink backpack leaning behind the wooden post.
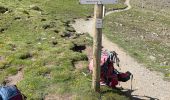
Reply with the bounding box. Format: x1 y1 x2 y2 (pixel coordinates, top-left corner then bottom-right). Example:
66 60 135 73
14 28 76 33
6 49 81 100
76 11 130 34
89 50 132 88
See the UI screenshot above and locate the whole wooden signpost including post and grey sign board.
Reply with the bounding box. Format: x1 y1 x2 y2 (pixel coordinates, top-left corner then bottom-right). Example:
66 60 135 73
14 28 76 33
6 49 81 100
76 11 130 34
79 0 117 92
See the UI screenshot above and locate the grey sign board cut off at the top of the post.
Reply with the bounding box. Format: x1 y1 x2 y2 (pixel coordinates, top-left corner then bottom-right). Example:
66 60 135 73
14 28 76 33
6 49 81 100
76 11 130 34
79 0 118 4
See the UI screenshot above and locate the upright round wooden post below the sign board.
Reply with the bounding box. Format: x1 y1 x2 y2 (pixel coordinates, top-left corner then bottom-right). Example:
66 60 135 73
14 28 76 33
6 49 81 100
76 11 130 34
92 4 103 92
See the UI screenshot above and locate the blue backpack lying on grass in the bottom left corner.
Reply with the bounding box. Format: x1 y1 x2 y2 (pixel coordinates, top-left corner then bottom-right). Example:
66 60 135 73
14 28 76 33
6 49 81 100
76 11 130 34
0 85 26 100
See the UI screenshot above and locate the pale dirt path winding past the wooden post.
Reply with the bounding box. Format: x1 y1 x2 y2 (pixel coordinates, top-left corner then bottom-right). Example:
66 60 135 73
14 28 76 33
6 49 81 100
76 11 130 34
73 0 170 100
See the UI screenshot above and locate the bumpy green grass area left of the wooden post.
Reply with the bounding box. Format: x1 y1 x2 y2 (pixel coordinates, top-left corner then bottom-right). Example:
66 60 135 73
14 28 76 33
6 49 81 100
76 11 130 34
0 0 128 100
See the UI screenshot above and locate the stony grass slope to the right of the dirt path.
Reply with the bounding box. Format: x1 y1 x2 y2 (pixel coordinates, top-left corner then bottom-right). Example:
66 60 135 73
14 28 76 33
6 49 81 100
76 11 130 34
104 0 170 78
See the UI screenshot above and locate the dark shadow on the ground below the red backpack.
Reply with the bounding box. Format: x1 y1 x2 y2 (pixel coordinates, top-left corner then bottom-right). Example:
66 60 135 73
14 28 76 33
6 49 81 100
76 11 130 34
101 88 159 100
